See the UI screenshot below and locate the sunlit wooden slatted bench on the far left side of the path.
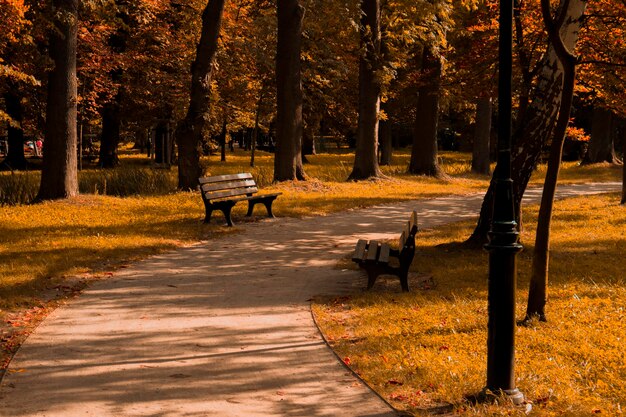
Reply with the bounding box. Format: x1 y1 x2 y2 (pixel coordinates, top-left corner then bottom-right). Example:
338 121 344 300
198 173 282 226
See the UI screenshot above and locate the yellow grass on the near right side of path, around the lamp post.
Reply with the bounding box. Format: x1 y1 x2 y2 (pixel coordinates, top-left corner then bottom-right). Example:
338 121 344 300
313 195 626 416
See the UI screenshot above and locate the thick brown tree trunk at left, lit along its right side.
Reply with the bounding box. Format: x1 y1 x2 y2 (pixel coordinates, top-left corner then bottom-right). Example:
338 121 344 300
37 0 78 200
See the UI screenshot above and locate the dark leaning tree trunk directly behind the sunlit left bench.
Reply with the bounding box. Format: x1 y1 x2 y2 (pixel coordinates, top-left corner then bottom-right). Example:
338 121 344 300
175 0 224 190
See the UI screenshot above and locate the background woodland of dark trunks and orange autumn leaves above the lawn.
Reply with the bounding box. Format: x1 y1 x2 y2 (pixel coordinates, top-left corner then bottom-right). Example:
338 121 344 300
0 0 626 188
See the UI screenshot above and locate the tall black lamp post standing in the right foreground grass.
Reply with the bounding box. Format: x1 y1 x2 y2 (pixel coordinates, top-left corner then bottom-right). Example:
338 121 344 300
484 0 524 404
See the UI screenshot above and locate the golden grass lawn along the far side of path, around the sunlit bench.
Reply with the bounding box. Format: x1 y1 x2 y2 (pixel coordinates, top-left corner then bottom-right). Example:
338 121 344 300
0 149 621 376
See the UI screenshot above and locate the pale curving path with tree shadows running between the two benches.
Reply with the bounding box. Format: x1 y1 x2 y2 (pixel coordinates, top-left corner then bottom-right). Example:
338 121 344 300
0 183 621 417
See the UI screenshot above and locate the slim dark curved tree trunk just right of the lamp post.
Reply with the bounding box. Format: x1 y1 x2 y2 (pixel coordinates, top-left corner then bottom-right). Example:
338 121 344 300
525 0 577 321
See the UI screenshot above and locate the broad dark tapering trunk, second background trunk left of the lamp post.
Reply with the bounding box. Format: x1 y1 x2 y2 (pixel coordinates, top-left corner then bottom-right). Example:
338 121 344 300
409 48 445 177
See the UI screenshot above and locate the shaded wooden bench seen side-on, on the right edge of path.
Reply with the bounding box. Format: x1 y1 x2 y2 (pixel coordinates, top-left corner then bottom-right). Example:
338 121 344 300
352 211 418 291
